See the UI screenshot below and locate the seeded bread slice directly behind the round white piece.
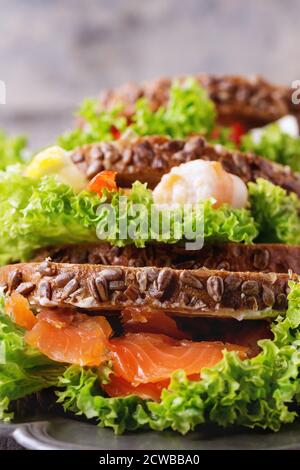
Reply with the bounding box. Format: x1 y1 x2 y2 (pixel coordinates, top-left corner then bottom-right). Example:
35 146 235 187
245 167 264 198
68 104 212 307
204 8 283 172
71 136 300 196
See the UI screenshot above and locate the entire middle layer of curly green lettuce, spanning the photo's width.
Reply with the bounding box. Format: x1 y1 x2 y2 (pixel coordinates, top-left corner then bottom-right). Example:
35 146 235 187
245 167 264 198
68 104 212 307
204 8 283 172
0 166 300 264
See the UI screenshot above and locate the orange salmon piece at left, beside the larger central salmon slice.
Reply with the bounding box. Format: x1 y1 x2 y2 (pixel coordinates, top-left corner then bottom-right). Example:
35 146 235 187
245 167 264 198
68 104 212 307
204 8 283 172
25 309 112 366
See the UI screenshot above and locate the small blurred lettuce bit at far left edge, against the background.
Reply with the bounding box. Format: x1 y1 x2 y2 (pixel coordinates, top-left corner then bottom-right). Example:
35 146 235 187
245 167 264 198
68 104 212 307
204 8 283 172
0 130 30 170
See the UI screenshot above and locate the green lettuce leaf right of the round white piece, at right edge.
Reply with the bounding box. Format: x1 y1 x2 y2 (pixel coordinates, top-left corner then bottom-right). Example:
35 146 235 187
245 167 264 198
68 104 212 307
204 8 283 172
248 178 300 245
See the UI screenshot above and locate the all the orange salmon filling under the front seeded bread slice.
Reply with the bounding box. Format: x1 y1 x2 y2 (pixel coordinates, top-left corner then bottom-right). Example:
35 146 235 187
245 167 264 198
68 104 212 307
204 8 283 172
8 297 248 400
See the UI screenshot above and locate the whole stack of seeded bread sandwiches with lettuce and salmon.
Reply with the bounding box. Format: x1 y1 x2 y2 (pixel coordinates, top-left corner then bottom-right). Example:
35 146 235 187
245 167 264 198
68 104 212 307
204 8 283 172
0 75 300 433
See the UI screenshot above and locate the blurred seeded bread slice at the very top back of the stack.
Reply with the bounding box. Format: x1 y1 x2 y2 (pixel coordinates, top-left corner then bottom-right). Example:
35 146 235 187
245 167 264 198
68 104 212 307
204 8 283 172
99 74 300 128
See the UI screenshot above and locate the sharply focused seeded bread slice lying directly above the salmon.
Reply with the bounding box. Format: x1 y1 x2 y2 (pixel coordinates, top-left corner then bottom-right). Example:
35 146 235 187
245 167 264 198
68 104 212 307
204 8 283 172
0 261 298 319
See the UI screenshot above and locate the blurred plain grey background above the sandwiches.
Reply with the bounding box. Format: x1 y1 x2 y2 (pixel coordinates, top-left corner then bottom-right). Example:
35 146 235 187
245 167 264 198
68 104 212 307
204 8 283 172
0 0 300 147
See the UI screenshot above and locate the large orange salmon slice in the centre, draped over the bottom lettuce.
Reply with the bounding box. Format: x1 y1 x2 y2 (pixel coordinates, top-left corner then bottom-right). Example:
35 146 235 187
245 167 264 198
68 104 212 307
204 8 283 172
109 333 248 386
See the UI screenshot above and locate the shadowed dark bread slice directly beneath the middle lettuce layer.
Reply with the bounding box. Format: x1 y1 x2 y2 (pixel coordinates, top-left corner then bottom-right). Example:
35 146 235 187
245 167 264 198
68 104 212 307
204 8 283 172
32 242 300 274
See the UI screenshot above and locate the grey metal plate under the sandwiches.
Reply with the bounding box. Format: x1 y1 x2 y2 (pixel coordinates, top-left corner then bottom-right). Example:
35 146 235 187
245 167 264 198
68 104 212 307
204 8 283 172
0 418 300 451
